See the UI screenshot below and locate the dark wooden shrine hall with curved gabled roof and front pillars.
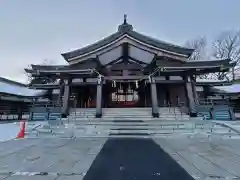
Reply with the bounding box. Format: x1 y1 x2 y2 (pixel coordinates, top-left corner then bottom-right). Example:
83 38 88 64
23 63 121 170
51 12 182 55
25 16 232 117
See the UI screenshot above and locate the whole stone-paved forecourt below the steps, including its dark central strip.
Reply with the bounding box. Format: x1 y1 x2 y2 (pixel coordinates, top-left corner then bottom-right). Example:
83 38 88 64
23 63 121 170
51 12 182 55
0 137 240 180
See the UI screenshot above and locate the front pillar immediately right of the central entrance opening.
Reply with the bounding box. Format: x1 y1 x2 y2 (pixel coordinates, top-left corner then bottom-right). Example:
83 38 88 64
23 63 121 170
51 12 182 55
149 77 159 117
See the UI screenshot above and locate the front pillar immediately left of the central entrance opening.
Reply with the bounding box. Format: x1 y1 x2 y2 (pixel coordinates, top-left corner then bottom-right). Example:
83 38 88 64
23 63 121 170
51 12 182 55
96 76 103 118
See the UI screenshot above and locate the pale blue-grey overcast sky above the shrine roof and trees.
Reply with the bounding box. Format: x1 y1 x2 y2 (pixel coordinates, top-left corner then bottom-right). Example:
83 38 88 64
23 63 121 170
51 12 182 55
0 0 240 82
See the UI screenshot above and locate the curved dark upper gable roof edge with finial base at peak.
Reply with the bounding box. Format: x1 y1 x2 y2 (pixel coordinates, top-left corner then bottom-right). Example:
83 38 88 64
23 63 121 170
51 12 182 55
62 21 193 61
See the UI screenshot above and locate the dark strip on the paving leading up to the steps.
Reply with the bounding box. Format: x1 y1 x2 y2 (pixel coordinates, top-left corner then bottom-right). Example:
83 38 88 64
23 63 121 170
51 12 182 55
84 139 193 180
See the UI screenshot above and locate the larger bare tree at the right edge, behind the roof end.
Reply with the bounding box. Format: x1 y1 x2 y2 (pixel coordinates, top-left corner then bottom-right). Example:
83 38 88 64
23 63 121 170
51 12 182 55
212 31 240 80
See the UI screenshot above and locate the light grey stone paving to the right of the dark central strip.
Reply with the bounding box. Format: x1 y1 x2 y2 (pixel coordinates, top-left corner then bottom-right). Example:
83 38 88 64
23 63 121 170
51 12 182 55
155 138 240 179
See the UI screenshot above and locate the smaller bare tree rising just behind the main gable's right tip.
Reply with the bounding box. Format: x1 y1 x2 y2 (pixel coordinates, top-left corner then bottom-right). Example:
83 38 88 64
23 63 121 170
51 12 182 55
185 37 207 60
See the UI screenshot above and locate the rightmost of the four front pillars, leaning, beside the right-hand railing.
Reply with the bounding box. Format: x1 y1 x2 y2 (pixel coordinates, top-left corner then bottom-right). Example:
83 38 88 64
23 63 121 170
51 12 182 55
185 77 196 116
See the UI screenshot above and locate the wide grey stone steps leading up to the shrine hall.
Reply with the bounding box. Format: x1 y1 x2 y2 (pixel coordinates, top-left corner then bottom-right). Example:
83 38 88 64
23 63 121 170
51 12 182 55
56 108 236 138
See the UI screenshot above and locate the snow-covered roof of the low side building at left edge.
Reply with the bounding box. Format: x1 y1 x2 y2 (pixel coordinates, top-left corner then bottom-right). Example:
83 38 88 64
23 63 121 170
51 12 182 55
0 77 44 97
